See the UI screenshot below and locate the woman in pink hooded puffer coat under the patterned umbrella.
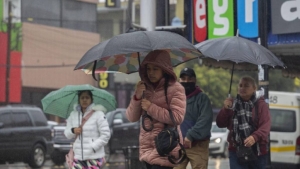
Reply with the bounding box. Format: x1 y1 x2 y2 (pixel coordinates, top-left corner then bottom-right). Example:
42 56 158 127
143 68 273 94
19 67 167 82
126 50 186 169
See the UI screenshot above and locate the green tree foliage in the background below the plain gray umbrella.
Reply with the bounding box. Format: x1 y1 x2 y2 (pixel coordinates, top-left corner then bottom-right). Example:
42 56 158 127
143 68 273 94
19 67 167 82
174 60 296 108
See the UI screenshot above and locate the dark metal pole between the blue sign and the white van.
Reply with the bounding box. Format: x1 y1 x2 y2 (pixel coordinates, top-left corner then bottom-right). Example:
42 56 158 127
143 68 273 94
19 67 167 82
258 0 272 169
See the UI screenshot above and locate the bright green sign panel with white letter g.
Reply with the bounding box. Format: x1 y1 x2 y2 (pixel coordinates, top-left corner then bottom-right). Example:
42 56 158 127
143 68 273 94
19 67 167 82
207 0 234 39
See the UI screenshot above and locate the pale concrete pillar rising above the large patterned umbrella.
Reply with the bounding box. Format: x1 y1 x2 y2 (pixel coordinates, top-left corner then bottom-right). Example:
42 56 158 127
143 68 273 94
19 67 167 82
140 0 156 31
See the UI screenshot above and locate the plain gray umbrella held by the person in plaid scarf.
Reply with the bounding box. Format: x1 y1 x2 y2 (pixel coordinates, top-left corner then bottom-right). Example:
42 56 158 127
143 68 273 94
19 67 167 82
195 36 285 94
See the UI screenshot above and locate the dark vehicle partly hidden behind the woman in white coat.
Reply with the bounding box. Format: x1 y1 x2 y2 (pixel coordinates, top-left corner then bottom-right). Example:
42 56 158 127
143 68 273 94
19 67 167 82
51 108 140 165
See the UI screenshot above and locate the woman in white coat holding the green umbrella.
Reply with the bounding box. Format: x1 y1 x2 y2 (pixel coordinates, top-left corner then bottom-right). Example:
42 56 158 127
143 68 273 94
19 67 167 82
64 90 110 169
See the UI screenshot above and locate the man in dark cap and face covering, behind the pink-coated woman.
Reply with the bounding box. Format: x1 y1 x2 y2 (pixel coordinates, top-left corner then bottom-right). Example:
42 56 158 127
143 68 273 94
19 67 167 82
175 68 213 169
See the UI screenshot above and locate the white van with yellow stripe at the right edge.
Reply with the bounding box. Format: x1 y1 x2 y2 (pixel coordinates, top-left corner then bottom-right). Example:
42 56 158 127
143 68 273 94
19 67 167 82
269 91 300 169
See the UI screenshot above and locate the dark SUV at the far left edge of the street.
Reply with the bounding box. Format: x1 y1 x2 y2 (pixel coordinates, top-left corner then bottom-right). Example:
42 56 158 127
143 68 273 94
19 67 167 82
0 105 53 168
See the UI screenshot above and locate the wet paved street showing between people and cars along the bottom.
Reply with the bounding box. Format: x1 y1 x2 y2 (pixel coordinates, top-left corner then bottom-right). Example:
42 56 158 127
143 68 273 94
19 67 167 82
0 154 229 169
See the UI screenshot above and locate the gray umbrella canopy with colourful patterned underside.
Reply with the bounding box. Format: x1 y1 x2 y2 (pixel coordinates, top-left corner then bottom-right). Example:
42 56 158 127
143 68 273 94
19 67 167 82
75 31 201 74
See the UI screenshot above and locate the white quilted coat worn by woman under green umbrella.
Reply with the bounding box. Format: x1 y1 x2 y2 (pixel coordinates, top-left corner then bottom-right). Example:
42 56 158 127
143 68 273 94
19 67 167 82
64 104 110 160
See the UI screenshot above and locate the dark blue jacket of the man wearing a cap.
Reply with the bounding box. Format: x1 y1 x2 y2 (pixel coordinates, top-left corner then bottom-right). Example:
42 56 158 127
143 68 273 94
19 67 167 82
180 87 213 141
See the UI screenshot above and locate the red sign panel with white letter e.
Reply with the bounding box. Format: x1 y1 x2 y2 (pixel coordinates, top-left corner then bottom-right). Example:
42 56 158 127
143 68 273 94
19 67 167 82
194 0 207 42
